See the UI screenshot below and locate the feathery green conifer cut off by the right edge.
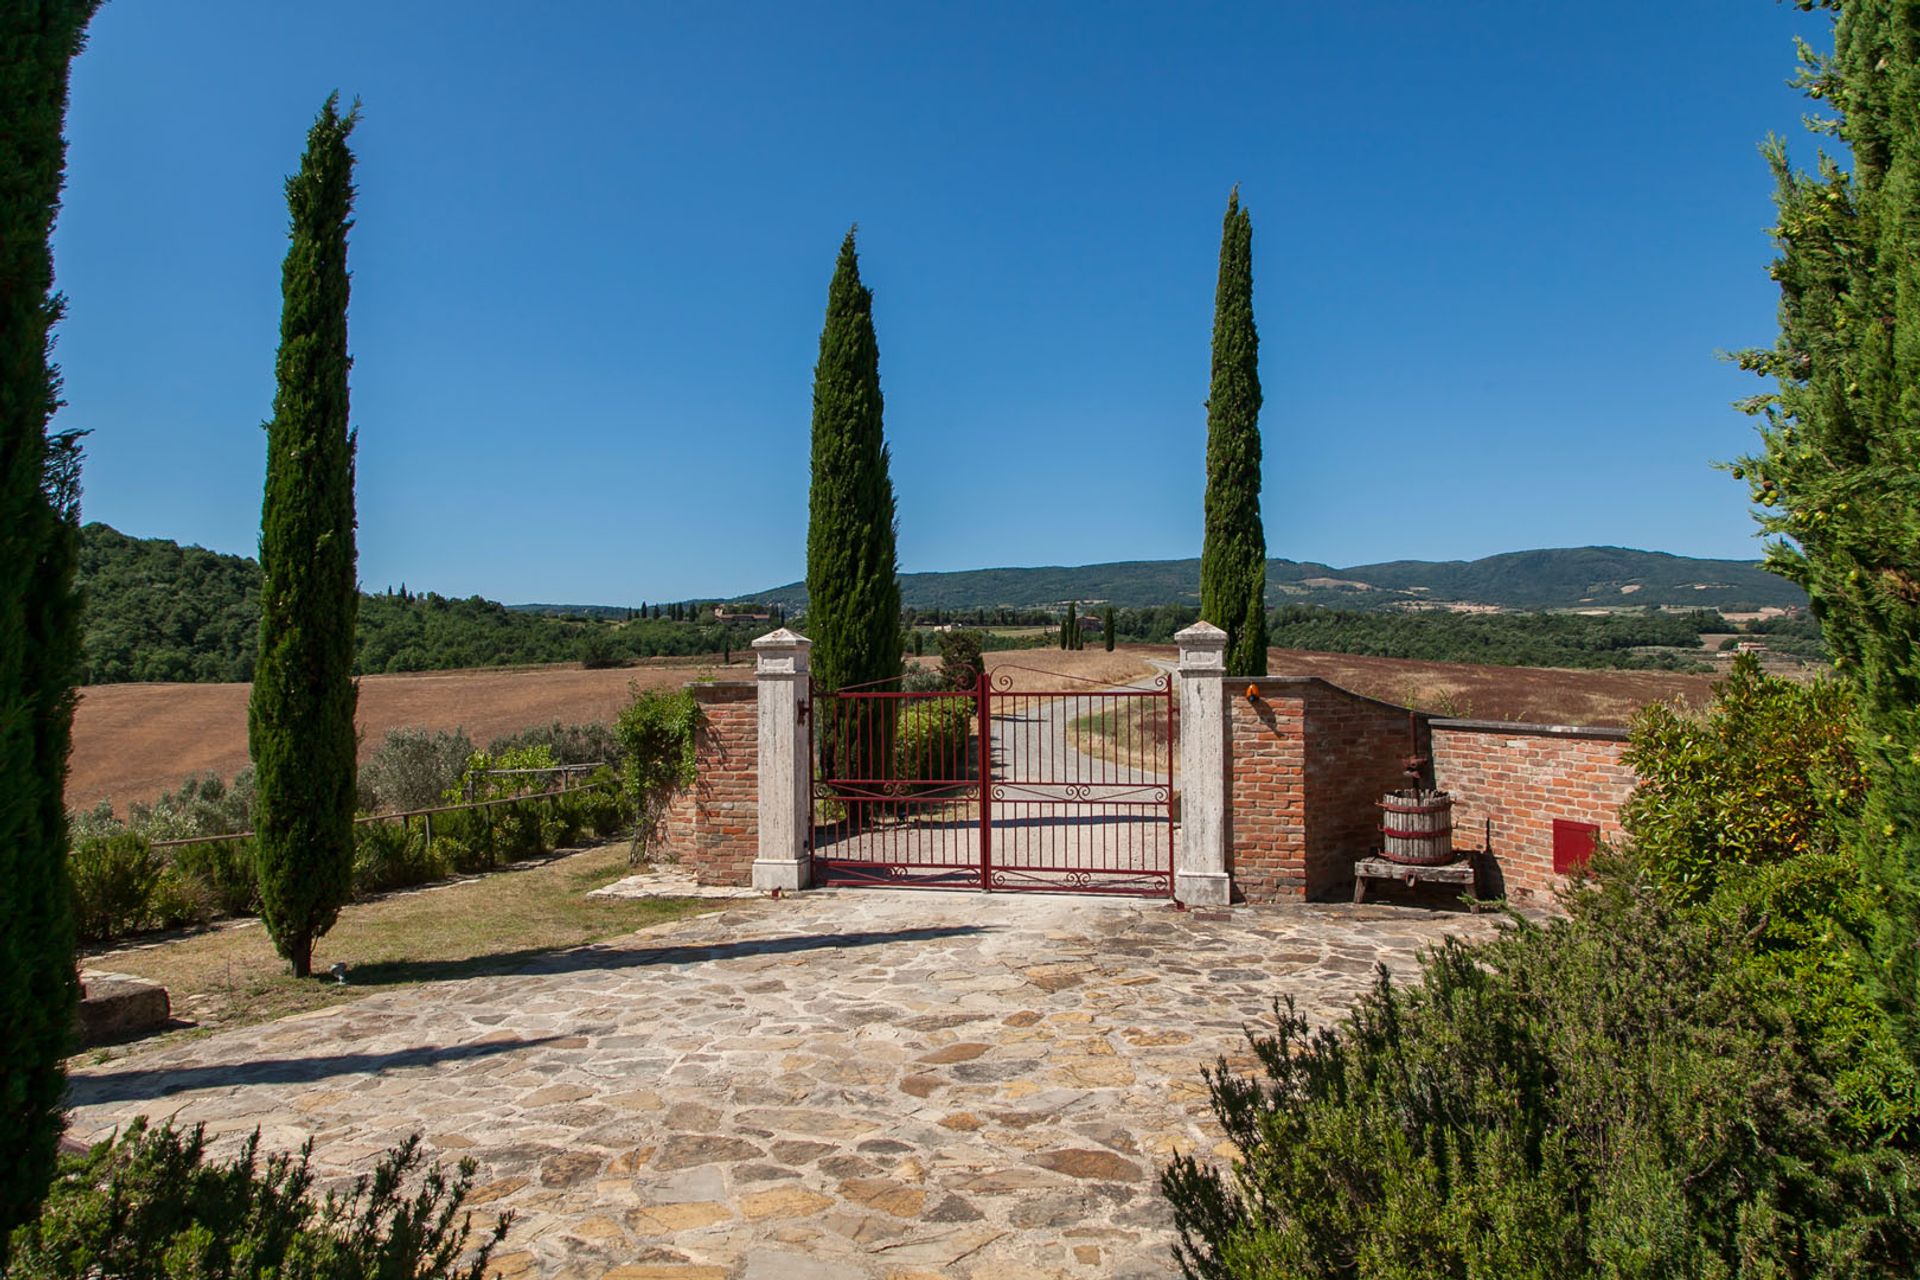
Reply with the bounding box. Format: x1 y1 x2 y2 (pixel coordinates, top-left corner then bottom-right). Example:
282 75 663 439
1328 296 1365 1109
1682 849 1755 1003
1734 2 1920 1028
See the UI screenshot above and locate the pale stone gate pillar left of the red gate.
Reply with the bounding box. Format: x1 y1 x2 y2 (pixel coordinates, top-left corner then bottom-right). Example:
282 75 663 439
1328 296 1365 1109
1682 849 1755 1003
753 628 814 890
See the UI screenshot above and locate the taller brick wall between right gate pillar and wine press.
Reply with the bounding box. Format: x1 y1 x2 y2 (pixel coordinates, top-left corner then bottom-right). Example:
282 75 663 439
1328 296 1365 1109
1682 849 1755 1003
1227 676 1425 902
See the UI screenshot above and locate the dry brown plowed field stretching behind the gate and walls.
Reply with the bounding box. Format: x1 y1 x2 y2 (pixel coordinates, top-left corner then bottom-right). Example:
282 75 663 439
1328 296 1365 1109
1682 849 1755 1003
67 647 1709 812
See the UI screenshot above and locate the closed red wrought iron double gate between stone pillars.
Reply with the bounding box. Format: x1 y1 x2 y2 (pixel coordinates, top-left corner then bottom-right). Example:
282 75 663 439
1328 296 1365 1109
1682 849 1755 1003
808 666 1175 898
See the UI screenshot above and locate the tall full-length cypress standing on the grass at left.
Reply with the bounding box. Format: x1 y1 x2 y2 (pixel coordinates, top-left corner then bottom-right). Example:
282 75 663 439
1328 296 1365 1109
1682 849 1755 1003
248 94 359 977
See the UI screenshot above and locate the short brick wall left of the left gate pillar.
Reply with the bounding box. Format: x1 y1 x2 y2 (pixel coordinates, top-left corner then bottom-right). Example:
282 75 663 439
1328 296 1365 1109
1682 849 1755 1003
660 679 760 885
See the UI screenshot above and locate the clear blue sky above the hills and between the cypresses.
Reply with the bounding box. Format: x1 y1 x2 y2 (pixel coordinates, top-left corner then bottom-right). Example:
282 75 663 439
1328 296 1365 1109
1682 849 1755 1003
56 0 1824 604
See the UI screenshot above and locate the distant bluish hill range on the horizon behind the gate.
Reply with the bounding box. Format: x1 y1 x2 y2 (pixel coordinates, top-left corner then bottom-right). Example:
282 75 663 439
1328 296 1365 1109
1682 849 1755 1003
737 547 1807 612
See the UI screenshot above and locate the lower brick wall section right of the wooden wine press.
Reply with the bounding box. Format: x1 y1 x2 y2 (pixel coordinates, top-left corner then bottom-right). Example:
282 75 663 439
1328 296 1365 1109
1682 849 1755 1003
1430 720 1634 900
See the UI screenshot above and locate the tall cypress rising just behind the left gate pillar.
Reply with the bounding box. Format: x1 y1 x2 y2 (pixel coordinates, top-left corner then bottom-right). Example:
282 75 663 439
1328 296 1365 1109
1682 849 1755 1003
806 230 900 777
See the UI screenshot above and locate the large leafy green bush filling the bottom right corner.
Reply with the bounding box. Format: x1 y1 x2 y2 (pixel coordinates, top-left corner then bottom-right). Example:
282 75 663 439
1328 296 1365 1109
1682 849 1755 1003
1162 856 1920 1280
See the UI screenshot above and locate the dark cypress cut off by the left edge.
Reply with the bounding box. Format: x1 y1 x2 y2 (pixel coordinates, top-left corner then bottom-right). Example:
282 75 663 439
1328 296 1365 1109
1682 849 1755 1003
0 0 100 1268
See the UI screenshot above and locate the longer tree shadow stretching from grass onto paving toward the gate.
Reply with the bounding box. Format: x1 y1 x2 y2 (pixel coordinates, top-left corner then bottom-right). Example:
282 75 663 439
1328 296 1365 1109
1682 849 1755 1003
348 925 993 986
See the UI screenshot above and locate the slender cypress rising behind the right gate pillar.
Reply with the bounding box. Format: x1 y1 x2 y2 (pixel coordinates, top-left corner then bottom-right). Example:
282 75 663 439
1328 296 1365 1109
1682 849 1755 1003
1200 186 1267 676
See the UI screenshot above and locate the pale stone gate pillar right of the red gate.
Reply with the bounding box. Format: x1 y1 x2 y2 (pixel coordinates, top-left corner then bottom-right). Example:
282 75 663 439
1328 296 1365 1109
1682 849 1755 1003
1173 622 1233 906
